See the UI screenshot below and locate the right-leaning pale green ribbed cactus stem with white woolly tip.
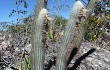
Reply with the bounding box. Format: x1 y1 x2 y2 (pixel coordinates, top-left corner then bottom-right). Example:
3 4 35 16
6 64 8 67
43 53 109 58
56 1 84 70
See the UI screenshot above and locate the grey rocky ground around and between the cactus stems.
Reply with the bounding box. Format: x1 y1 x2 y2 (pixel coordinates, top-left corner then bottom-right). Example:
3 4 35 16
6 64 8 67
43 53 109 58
0 30 110 70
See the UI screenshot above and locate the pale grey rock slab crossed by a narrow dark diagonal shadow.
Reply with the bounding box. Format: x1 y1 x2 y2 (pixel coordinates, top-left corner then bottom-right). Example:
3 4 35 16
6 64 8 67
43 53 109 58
68 42 110 70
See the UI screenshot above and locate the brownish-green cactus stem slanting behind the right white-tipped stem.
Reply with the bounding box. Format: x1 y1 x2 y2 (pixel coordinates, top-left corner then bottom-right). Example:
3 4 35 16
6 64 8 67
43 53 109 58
66 0 99 65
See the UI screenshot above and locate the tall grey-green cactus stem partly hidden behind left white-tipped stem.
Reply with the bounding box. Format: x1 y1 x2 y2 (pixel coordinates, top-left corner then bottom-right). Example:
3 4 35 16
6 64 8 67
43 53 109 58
30 0 48 70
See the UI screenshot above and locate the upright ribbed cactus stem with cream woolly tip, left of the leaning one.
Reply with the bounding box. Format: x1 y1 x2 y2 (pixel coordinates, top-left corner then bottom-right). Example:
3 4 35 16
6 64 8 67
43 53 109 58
33 8 48 70
